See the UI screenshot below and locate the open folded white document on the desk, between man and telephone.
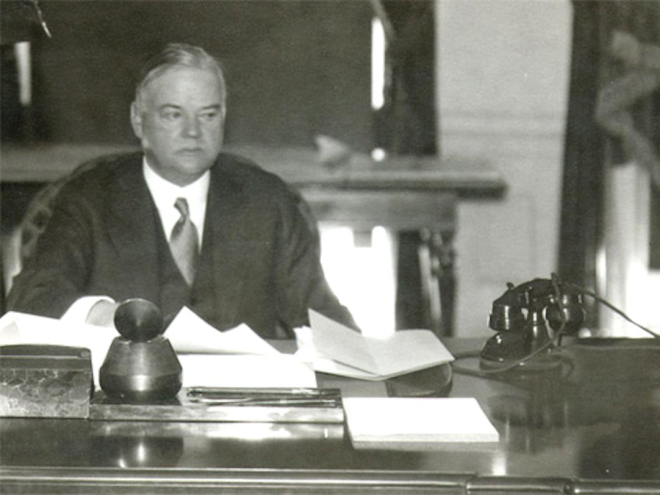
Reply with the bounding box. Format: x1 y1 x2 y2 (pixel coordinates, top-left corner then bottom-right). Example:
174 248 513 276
298 310 454 380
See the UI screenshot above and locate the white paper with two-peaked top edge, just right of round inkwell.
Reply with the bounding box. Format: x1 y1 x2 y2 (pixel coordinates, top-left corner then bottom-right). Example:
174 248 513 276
165 307 280 355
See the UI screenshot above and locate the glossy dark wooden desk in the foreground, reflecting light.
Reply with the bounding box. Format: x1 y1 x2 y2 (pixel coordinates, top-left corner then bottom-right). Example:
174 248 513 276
0 339 660 495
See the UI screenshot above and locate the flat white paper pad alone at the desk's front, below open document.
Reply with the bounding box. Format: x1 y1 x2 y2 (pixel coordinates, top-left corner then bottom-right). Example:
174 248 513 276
343 397 499 448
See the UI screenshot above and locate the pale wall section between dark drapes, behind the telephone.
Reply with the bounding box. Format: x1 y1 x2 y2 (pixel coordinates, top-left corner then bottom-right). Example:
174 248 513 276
437 0 572 336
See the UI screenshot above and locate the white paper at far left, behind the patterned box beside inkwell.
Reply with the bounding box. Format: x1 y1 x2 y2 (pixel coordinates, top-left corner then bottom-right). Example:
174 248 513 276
0 311 119 384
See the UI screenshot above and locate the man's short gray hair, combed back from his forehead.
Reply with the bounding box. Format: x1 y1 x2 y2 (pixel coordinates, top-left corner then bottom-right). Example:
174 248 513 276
135 43 227 104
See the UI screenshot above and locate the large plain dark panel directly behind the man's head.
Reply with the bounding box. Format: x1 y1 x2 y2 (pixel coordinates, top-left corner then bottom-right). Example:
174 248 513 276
25 0 373 151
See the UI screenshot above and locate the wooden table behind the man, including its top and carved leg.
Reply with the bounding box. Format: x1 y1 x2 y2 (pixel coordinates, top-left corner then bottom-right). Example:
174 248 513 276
2 145 505 335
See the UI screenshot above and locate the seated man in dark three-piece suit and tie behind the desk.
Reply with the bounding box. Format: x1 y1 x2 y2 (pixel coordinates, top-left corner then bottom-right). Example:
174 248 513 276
8 44 355 338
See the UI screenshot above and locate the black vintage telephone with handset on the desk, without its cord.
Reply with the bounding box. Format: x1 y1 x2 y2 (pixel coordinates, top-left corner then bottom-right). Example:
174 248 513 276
480 277 585 369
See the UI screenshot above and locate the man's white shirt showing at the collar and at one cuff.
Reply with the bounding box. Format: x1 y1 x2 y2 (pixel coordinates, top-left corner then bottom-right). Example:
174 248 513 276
61 158 211 323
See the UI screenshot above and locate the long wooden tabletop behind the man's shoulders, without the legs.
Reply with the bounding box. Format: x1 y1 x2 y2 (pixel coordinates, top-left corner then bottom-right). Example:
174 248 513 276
2 144 506 197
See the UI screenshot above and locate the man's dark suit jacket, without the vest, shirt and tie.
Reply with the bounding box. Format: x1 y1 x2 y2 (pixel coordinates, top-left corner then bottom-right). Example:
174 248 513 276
8 153 355 337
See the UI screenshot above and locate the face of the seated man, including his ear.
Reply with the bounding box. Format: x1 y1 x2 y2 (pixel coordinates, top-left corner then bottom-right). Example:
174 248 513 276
131 66 225 186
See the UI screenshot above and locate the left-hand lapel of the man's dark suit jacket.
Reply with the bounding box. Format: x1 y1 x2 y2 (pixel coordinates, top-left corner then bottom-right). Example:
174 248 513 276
108 155 162 304
